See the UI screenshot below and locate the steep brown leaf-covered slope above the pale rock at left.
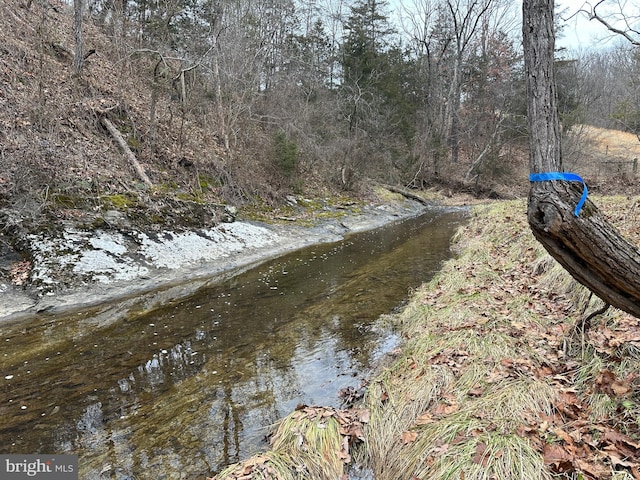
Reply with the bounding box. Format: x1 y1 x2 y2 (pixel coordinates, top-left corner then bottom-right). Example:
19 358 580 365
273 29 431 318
0 0 251 234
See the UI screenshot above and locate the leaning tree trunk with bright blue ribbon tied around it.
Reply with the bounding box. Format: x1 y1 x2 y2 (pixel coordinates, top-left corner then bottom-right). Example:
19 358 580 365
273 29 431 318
522 0 640 318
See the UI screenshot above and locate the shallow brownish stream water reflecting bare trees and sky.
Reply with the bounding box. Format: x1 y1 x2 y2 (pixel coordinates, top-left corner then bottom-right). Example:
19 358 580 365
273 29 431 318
0 210 465 479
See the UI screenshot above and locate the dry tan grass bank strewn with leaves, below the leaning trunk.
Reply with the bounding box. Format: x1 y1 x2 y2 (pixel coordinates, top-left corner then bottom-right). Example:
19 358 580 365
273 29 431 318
365 197 640 480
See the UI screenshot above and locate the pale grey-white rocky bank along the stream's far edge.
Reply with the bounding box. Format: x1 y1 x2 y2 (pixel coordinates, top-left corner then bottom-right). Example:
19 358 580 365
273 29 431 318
0 199 427 323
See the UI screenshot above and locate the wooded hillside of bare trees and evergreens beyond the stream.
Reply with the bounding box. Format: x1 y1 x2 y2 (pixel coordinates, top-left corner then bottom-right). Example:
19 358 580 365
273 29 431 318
0 0 638 233
